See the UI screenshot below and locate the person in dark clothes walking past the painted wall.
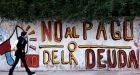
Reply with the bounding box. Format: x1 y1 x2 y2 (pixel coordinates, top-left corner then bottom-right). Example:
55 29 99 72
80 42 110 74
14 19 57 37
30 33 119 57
9 31 35 75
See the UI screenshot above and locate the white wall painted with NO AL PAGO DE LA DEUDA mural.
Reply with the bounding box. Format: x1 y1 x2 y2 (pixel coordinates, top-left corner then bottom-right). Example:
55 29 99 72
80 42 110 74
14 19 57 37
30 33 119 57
0 18 140 71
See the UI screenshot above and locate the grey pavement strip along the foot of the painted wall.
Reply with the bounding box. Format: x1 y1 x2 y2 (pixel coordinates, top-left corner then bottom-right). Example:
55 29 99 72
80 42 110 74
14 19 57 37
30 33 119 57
0 70 140 75
